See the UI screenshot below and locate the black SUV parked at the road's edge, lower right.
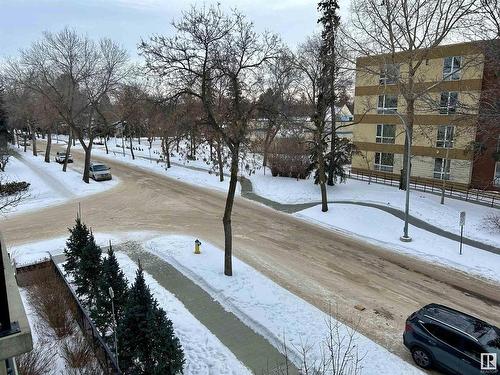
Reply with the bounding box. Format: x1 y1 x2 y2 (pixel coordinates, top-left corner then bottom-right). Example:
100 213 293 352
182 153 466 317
403 304 500 375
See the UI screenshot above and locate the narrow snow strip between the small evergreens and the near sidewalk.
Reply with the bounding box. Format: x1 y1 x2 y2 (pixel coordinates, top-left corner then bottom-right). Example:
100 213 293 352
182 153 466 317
116 252 251 375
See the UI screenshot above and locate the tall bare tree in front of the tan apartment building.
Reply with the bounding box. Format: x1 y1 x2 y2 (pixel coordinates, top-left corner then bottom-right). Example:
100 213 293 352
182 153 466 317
343 0 478 189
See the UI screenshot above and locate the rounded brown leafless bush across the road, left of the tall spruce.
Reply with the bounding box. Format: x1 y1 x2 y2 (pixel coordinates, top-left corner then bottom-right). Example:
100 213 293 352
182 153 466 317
268 138 309 179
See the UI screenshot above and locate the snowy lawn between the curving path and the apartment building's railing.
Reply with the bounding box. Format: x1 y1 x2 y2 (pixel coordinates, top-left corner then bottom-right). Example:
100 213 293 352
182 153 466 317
250 169 500 247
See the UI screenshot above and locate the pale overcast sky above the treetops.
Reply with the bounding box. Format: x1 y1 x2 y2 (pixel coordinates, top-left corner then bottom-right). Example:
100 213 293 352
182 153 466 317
0 0 350 59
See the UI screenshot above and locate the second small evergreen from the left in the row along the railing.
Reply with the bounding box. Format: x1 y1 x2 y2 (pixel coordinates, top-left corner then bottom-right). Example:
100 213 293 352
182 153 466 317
74 232 102 308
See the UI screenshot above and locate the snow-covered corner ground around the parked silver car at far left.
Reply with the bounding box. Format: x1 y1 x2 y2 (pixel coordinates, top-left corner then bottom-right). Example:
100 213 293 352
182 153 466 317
3 152 119 215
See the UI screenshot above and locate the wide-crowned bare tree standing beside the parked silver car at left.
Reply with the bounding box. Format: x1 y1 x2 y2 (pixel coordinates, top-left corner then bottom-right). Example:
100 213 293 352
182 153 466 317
7 28 128 183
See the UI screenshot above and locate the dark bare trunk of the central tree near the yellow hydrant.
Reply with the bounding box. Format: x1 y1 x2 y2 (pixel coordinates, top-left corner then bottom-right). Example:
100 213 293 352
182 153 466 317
222 146 239 276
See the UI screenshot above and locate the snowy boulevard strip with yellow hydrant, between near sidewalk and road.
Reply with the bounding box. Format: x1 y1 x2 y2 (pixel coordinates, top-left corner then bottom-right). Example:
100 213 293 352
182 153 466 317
145 235 421 375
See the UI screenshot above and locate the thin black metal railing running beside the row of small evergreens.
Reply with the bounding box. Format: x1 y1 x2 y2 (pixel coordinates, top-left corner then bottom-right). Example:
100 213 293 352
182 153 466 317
50 257 122 375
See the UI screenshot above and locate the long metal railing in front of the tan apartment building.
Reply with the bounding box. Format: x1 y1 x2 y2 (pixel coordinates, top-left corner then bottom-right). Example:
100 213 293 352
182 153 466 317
348 169 500 208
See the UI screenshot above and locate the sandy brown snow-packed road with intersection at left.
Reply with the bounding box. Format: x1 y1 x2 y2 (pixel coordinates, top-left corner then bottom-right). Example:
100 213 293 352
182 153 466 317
0 143 500 361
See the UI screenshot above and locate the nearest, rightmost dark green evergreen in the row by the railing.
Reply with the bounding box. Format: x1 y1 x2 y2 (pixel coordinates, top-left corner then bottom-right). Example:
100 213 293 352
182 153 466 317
118 268 184 375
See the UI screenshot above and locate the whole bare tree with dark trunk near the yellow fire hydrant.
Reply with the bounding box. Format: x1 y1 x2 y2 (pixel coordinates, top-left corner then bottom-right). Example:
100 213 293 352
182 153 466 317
140 6 279 276
